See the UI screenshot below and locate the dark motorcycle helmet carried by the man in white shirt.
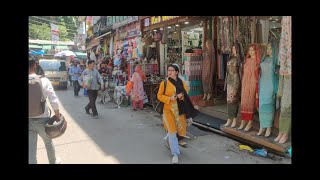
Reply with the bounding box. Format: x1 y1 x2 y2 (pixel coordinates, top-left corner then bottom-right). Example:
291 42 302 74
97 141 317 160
45 114 67 139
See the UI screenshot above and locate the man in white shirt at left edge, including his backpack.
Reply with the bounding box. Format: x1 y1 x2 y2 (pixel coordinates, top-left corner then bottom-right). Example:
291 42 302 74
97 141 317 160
29 60 61 164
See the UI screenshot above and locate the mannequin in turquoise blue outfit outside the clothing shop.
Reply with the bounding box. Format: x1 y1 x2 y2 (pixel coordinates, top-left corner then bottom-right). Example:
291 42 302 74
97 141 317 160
257 42 279 137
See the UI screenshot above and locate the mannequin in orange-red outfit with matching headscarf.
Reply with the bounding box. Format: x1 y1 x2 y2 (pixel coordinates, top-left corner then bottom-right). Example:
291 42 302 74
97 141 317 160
238 44 261 131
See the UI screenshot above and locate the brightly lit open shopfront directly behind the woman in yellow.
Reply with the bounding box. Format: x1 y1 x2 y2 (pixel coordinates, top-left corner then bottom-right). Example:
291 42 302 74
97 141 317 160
141 16 206 103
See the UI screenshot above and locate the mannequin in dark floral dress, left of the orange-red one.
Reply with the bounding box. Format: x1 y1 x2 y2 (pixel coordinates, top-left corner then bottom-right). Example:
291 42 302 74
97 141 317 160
224 45 241 128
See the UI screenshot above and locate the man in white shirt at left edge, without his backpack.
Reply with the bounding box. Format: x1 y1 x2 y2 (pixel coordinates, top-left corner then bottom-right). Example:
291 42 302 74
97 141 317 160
29 60 60 164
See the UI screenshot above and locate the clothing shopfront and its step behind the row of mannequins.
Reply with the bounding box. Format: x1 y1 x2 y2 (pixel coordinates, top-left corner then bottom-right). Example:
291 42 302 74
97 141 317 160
192 16 291 152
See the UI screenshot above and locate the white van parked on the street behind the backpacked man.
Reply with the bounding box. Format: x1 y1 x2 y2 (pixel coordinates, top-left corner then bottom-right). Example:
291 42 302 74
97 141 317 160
39 59 68 89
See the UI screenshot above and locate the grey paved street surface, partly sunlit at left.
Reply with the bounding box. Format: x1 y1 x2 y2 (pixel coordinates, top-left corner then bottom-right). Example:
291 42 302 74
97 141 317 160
38 87 291 164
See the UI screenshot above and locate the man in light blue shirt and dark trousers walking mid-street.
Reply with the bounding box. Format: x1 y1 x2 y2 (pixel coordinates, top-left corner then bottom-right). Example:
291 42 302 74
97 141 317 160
78 60 105 119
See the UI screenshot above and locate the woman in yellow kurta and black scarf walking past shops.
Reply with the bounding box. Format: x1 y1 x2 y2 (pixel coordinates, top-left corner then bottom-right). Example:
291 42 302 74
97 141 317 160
158 65 194 163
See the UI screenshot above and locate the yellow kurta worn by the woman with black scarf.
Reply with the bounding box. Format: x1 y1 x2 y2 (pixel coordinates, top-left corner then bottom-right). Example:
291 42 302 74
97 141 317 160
158 80 188 136
